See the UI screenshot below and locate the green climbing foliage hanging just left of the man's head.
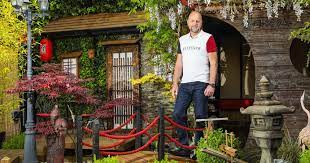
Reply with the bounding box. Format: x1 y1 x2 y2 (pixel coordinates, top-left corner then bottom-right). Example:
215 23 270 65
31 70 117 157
132 0 179 72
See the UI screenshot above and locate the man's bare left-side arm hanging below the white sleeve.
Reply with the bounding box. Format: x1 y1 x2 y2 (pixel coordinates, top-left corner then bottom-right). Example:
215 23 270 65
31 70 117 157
171 54 183 98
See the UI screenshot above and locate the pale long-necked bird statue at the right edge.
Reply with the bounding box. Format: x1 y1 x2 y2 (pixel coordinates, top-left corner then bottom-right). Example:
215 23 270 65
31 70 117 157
298 91 310 151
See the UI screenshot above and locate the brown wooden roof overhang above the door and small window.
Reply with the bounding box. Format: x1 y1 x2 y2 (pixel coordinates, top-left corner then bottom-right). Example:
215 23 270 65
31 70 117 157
42 12 146 34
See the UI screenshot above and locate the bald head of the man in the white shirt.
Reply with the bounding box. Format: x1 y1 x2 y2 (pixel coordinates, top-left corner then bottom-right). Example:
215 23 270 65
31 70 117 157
187 11 202 35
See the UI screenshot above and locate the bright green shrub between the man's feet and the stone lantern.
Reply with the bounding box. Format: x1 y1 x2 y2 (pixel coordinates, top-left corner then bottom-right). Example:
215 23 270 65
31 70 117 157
195 128 240 163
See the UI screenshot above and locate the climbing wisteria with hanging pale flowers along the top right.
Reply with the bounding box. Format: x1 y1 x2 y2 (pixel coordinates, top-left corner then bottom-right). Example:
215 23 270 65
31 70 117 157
131 0 310 68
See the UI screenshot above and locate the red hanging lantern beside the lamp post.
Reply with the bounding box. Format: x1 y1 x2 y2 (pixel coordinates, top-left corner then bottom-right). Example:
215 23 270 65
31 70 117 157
40 38 53 62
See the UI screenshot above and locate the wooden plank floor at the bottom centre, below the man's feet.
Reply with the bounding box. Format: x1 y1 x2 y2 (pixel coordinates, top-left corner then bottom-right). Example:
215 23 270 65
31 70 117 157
117 151 196 163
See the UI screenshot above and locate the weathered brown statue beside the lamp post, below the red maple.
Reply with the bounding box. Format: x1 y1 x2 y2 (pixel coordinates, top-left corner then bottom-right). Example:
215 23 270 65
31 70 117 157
46 105 67 163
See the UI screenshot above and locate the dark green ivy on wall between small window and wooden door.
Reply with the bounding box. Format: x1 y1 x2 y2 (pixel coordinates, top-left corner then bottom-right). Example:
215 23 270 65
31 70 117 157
54 36 107 99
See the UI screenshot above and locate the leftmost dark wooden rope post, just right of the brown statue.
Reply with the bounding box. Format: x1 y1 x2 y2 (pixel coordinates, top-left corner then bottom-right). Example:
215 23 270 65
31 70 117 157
75 116 83 163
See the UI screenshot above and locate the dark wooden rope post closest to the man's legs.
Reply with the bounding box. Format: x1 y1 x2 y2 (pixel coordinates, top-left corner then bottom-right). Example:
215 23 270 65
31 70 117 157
158 106 165 161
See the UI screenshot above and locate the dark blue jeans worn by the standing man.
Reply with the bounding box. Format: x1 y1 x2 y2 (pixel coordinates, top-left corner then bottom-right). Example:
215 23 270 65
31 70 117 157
172 82 208 145
